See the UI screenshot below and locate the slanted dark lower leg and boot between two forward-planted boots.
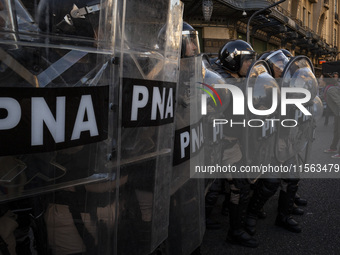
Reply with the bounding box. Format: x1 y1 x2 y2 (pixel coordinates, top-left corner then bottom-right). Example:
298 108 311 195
245 179 279 235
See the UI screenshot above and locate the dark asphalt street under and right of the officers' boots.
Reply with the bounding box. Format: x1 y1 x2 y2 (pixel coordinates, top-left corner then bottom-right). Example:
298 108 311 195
201 117 340 255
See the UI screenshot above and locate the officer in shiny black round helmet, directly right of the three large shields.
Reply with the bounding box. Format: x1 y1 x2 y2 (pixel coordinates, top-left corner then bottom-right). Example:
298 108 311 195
215 40 259 248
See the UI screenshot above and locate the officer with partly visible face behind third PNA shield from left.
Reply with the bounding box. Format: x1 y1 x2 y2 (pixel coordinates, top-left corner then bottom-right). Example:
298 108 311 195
165 22 204 255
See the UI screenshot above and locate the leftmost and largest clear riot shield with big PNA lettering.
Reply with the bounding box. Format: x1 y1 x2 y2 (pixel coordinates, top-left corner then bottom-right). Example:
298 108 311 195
0 0 118 254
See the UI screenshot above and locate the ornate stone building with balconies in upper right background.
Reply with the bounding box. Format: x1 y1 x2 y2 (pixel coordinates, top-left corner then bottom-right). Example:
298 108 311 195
182 0 340 71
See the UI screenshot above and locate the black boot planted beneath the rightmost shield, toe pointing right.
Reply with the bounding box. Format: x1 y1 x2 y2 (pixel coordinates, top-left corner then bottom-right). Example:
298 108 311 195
275 188 301 233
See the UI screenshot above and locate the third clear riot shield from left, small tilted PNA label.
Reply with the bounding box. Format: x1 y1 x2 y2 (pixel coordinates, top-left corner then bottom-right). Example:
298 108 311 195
166 56 205 254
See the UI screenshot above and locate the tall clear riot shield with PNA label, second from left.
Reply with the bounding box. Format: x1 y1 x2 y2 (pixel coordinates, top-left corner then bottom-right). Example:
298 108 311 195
115 0 182 254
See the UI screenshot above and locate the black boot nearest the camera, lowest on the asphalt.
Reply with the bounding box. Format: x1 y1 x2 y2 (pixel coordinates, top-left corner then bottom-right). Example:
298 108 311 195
227 203 259 248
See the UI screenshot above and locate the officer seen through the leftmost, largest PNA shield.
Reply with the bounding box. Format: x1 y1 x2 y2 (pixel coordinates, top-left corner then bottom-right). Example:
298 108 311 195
37 0 119 254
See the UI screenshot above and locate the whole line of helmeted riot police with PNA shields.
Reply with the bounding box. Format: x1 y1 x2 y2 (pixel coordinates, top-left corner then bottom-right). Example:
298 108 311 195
0 0 319 255
